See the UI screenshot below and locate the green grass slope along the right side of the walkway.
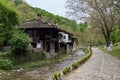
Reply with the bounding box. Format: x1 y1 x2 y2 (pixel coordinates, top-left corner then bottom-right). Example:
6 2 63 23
101 45 120 59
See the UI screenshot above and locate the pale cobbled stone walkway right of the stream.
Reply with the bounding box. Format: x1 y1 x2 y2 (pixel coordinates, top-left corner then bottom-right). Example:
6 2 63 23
62 48 120 80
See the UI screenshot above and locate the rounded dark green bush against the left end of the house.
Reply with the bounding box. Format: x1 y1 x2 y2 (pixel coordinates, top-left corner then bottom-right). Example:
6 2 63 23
10 33 29 56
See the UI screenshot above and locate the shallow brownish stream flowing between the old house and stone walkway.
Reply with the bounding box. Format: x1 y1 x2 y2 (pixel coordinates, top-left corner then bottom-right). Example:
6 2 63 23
0 50 85 80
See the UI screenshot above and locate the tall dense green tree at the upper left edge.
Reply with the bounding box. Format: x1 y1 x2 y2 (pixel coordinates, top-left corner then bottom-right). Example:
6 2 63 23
0 0 19 46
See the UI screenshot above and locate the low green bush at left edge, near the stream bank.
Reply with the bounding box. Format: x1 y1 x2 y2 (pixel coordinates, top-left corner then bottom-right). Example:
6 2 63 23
0 59 12 70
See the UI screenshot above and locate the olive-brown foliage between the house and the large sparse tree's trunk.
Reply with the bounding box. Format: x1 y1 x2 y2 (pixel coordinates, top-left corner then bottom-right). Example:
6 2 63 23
81 27 105 46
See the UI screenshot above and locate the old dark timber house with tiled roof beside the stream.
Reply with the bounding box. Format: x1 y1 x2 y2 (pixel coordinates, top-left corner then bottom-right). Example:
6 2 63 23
20 19 76 58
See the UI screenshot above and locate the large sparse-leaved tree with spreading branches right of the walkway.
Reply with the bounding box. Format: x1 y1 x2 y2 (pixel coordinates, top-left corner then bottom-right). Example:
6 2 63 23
66 0 117 47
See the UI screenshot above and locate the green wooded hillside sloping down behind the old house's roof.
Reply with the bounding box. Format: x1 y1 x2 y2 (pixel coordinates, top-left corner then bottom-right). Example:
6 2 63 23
4 0 87 45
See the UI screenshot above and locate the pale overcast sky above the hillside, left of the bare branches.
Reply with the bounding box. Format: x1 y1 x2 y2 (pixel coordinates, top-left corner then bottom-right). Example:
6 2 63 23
25 0 66 17
